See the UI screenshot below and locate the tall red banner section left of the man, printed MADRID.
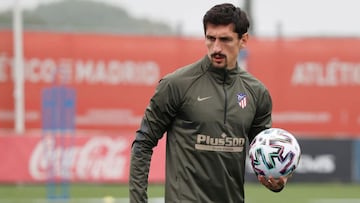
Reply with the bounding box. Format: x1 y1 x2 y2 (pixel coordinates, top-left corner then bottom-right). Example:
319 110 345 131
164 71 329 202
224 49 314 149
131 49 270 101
0 32 205 130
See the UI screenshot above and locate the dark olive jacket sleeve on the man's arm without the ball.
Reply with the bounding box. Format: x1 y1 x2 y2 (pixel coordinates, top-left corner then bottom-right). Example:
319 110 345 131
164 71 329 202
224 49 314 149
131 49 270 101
129 77 178 203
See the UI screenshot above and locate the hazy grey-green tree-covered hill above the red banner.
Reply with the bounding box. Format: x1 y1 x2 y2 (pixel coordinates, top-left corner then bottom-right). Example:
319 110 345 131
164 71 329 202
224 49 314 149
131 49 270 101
0 0 176 35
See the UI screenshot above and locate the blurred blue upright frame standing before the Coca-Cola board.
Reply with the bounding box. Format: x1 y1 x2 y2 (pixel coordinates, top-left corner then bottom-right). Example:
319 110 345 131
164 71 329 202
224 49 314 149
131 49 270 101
42 86 76 199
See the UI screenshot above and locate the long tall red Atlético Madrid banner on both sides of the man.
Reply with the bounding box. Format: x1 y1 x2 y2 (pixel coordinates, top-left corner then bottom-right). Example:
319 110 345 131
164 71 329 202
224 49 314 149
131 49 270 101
0 31 360 137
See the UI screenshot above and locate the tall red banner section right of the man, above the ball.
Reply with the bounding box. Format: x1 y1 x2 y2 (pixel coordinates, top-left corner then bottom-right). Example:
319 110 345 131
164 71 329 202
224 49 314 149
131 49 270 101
248 38 360 136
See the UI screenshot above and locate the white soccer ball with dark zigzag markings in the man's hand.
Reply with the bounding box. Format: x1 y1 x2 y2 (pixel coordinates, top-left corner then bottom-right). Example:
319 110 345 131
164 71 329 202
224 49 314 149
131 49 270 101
249 128 301 178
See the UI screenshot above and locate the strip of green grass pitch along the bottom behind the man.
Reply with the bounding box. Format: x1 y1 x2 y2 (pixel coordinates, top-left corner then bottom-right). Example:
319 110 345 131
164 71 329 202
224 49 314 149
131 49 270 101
0 182 360 203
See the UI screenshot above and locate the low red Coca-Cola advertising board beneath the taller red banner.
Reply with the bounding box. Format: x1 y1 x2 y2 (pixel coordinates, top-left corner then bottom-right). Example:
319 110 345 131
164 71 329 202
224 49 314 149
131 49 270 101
0 132 165 183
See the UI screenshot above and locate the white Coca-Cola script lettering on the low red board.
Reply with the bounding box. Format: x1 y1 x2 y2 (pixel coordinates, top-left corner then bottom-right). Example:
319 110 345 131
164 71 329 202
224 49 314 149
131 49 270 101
29 136 129 180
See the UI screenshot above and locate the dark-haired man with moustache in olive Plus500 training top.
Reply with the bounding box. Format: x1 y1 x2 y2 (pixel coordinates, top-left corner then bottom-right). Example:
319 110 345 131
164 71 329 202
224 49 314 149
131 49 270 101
129 4 287 203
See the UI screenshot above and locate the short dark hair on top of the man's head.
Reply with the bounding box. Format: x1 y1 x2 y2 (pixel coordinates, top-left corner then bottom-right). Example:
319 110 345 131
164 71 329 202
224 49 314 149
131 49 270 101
203 3 250 38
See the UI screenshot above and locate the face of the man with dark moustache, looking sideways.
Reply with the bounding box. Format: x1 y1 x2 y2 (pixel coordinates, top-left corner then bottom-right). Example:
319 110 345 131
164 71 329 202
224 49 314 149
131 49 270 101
205 23 248 69
